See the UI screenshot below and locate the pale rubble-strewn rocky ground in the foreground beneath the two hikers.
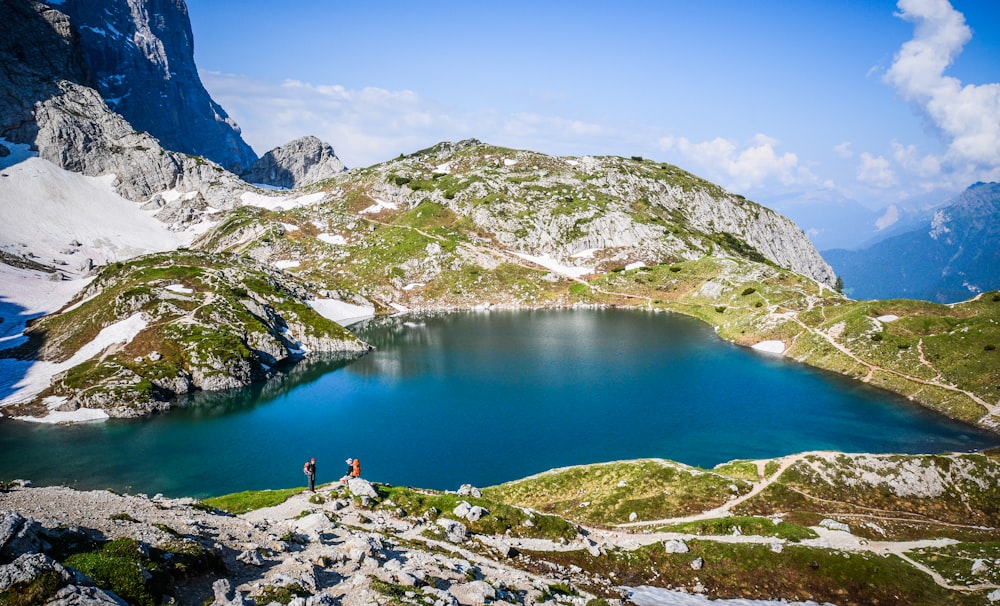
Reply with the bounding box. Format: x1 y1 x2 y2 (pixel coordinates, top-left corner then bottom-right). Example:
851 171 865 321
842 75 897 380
0 479 624 606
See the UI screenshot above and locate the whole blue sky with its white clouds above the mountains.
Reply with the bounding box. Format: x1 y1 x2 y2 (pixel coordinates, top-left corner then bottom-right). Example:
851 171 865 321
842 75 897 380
187 0 1000 218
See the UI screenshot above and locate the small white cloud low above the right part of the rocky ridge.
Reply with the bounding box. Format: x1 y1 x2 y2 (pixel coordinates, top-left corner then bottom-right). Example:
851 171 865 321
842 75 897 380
660 134 817 190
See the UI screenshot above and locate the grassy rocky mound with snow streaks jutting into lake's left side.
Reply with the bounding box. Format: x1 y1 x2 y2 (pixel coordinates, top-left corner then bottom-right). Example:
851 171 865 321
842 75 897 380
5 252 371 418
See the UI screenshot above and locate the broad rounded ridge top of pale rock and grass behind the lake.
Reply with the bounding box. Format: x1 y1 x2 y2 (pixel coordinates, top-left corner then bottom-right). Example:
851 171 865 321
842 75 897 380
338 140 835 286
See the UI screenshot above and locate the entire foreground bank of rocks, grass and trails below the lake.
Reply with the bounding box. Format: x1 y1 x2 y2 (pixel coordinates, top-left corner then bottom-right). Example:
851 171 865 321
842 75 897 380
0 453 1000 606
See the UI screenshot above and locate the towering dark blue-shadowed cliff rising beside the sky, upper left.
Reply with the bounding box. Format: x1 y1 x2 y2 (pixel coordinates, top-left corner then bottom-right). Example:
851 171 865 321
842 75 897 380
57 0 257 173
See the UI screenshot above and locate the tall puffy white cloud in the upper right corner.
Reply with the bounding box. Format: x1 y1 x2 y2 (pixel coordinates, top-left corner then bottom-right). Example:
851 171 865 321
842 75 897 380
885 0 1000 170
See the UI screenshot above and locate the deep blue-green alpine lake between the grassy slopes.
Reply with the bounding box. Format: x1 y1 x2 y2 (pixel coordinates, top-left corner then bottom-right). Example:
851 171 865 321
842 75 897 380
0 309 1000 497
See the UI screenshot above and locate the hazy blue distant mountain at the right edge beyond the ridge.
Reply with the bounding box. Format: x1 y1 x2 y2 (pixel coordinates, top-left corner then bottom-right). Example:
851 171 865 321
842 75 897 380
822 183 1000 303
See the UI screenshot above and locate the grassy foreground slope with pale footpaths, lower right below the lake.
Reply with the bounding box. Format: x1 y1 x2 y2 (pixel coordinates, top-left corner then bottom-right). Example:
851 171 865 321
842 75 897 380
484 452 1000 605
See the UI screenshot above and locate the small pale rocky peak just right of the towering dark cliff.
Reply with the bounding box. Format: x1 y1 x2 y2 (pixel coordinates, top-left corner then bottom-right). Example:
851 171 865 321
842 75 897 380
241 137 346 189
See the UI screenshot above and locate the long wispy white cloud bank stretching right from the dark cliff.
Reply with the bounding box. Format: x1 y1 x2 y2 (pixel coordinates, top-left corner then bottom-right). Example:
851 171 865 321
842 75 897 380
201 72 655 167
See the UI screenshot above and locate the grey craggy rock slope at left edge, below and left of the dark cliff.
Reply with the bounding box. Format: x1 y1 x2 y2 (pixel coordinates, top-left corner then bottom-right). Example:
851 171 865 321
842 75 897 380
0 0 254 216
